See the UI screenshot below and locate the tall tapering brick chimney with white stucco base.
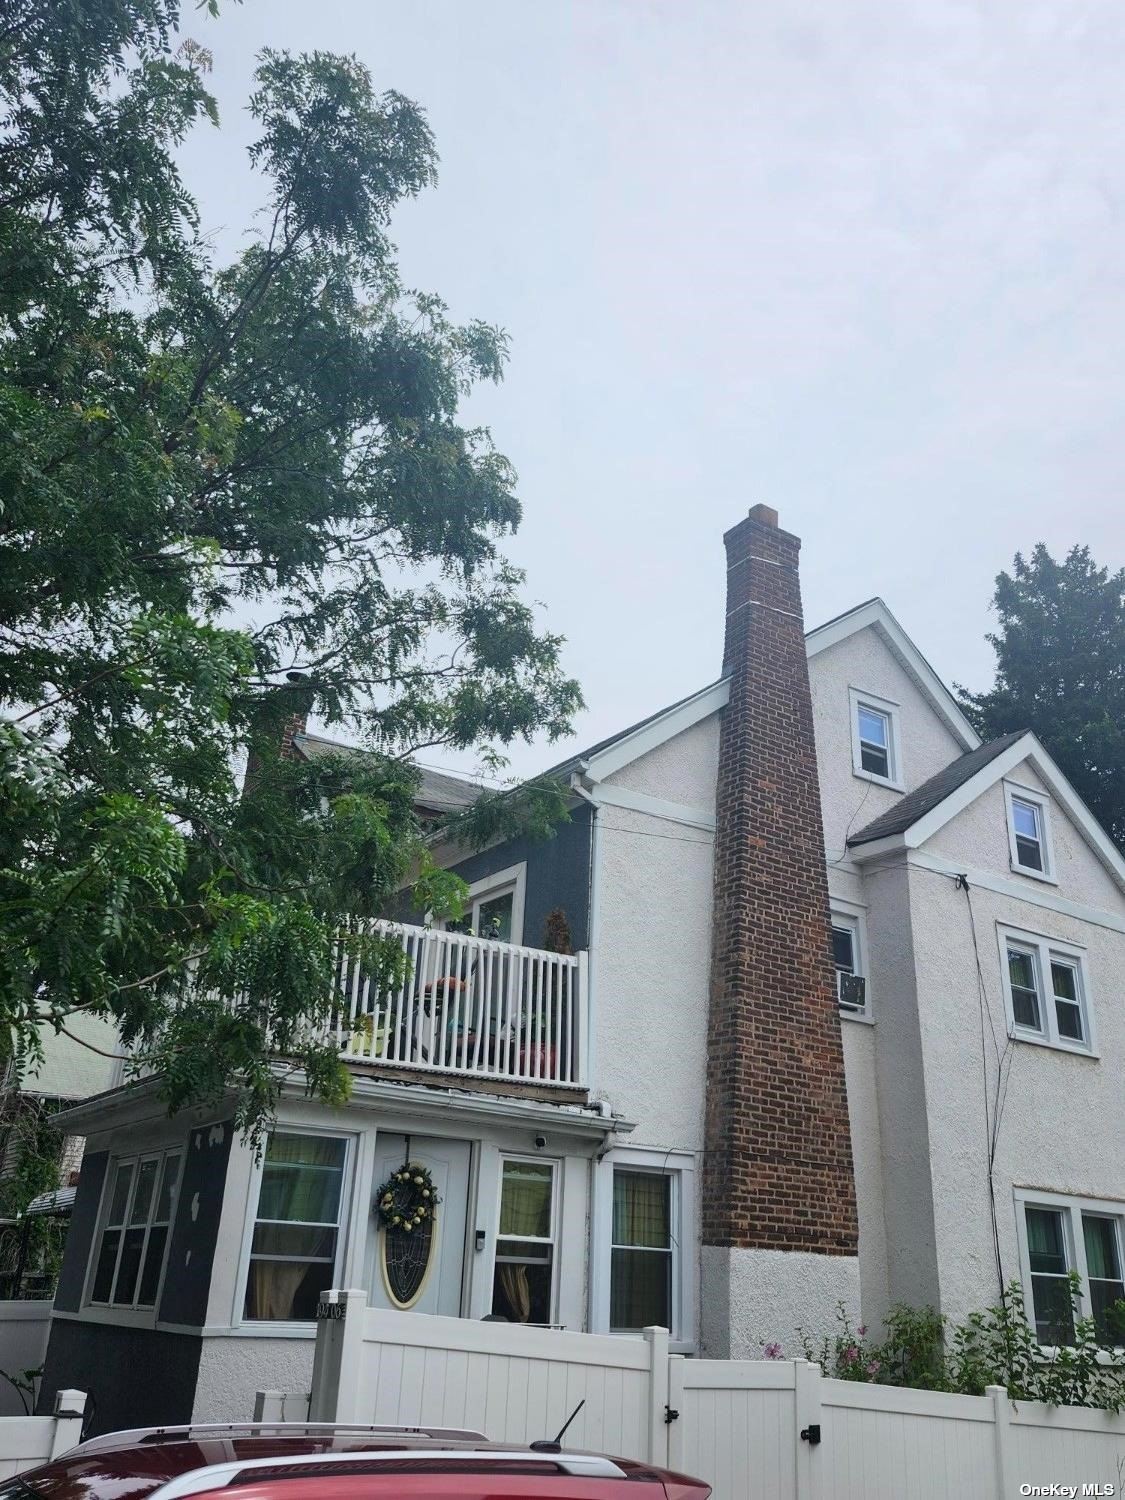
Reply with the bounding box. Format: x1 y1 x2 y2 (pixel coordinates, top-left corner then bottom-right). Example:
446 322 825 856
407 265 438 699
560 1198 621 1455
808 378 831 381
702 506 858 1358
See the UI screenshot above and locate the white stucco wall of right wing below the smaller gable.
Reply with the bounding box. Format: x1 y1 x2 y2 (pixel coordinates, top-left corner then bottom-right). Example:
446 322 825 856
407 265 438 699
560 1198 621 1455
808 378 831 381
909 774 1125 1317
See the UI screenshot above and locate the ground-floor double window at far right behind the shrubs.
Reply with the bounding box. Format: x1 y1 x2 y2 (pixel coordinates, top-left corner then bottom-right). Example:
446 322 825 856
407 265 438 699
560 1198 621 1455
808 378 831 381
1017 1193 1125 1347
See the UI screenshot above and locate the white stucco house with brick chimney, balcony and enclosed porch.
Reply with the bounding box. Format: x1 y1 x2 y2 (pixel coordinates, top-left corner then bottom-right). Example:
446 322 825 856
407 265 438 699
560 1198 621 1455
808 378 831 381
44 506 1125 1427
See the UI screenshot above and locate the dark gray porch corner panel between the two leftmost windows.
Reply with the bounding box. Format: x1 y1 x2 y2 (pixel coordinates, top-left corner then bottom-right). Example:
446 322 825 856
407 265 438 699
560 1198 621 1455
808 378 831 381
159 1121 240 1328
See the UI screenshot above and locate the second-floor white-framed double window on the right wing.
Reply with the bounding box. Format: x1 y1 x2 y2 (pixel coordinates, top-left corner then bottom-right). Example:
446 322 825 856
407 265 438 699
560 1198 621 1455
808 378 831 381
1001 929 1092 1052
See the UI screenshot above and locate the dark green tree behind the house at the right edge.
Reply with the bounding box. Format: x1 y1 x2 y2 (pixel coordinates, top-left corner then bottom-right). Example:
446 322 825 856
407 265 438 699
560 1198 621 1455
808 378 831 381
960 543 1125 849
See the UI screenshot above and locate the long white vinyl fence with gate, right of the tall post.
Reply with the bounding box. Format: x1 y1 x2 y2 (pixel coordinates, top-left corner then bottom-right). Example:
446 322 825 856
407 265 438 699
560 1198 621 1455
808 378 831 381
288 1292 1125 1500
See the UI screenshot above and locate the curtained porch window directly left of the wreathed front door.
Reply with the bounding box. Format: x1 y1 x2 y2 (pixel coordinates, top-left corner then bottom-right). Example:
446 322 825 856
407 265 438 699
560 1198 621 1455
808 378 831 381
243 1131 348 1323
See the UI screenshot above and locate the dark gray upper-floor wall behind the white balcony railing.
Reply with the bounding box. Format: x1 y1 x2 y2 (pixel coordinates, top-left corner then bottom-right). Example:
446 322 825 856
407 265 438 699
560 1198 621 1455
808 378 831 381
452 803 593 953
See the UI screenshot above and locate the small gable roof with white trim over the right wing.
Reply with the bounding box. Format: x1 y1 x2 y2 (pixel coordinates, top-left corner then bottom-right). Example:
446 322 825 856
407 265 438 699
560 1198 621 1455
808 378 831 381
848 729 1125 891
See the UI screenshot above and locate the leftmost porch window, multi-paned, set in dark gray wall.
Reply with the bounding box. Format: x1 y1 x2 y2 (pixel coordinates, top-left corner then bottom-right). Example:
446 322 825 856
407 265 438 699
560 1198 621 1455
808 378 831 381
90 1149 183 1308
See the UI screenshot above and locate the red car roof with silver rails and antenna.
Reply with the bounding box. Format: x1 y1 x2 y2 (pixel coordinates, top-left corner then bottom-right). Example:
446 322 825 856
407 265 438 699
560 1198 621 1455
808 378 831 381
0 1422 711 1500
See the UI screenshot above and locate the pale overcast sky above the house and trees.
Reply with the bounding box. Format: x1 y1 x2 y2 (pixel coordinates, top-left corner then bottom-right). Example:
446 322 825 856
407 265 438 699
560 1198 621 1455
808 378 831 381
182 0 1125 774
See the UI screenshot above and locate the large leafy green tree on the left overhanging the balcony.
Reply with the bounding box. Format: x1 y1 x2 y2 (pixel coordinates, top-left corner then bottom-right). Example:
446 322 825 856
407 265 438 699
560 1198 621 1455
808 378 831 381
0 0 581 1130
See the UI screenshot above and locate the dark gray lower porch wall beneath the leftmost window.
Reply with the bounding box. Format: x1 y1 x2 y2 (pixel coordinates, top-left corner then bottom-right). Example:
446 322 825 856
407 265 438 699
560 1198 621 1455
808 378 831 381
39 1326 202 1436
